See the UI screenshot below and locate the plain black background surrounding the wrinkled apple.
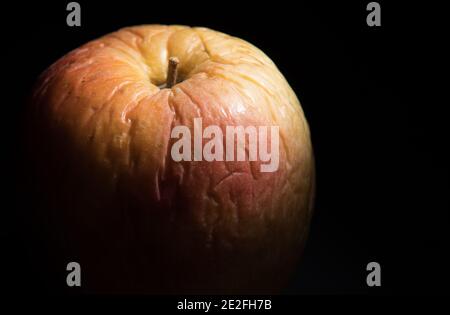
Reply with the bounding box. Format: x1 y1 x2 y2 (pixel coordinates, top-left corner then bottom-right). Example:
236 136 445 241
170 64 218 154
0 0 450 294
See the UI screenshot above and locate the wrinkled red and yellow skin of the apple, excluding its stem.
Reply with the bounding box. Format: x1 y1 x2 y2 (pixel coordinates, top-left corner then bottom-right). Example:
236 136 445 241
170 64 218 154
27 25 315 294
